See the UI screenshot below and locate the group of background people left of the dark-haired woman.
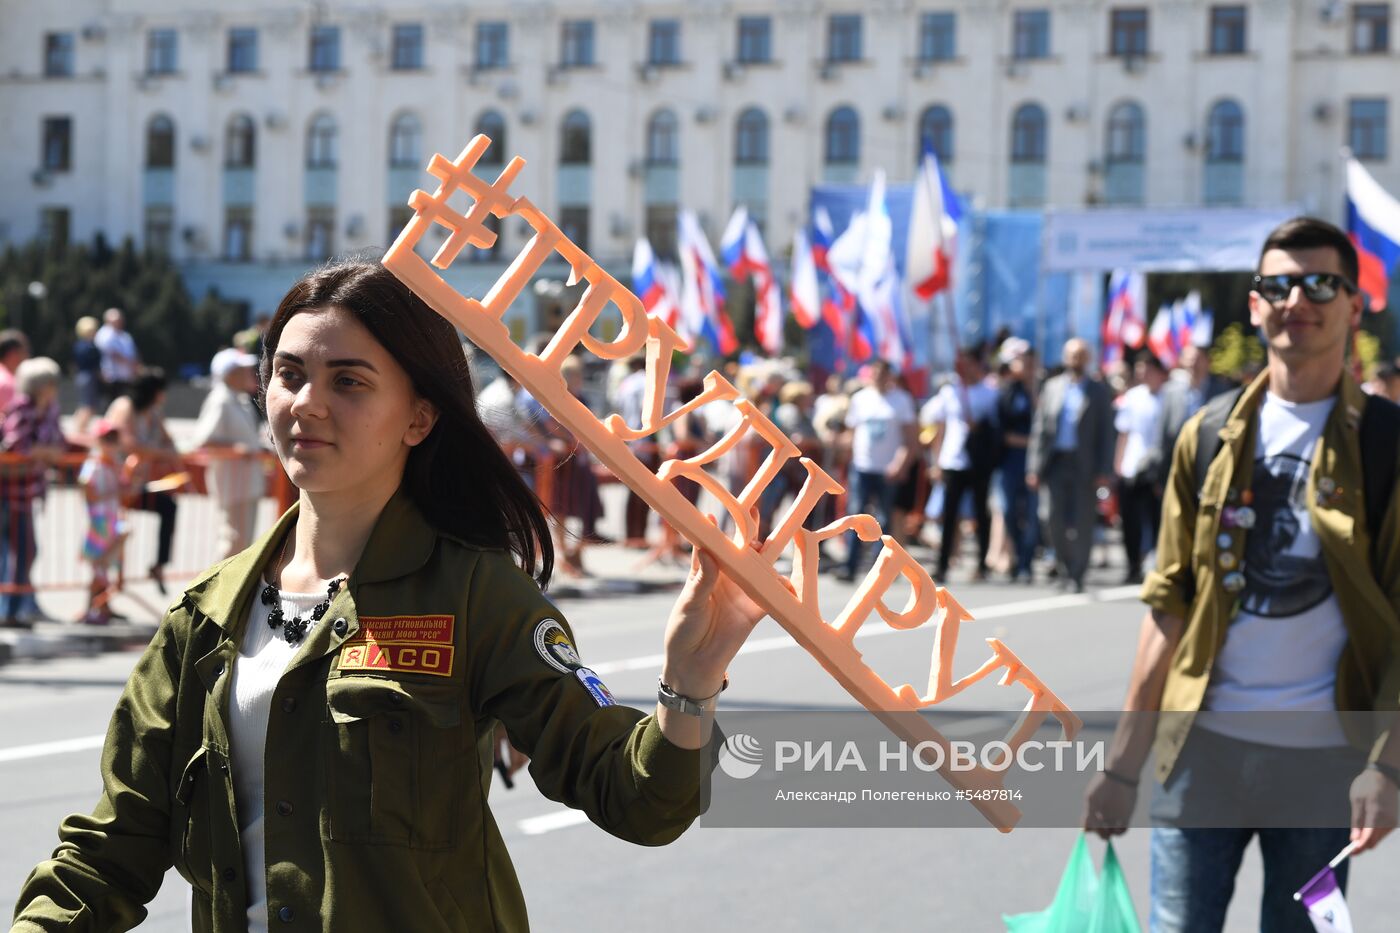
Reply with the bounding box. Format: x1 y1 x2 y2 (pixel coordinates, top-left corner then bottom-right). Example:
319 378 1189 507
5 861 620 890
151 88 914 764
0 308 266 628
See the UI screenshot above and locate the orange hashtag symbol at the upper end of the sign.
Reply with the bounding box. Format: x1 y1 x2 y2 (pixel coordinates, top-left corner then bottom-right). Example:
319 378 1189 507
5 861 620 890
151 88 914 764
409 136 525 269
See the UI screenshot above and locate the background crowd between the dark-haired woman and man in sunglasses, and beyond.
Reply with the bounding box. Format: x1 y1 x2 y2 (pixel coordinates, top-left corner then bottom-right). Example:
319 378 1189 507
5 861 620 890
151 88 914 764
479 326 1400 591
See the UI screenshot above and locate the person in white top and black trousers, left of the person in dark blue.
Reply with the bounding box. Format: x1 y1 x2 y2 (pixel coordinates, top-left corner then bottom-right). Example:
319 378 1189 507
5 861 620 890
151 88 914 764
918 350 997 581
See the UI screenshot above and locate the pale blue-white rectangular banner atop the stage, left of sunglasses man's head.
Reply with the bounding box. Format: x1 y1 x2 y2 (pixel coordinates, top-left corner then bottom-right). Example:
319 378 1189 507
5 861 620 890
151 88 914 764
1042 207 1299 272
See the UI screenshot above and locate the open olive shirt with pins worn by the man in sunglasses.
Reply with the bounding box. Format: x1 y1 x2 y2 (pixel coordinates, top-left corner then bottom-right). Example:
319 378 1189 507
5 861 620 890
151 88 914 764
1142 371 1400 782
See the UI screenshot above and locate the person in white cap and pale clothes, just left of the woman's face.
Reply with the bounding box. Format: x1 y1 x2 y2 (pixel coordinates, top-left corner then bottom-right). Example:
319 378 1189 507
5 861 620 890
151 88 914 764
186 347 267 558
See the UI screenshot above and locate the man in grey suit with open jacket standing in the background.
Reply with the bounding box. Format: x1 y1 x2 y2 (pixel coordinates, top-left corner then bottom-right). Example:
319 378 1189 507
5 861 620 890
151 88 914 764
1026 338 1114 593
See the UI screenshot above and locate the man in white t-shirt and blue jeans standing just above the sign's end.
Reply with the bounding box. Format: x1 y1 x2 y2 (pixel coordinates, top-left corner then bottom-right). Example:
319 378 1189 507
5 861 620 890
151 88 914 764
837 360 918 580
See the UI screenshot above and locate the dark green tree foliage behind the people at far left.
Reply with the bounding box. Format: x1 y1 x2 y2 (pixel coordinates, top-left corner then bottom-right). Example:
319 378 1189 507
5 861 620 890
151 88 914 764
0 235 245 374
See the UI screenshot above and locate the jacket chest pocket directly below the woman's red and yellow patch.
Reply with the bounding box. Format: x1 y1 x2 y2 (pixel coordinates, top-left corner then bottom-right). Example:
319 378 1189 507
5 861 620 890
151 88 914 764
323 677 470 849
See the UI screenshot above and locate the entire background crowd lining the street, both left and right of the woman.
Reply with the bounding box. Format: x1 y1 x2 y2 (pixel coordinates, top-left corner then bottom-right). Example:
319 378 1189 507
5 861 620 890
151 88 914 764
0 291 1400 626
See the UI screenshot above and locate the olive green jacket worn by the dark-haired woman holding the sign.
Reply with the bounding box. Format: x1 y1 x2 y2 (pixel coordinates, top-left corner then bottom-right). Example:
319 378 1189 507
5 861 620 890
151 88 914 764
14 489 714 933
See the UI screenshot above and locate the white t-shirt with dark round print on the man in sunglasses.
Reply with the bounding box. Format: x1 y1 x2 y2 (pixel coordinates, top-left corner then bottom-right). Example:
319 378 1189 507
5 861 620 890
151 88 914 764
1200 392 1347 748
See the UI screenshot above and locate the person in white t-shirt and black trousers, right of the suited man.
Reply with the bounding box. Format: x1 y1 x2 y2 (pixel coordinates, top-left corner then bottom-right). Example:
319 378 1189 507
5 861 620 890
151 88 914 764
1113 353 1166 583
